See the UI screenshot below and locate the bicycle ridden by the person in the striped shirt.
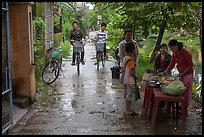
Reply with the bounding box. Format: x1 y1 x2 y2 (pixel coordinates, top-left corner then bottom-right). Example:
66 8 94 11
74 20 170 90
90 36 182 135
96 43 105 70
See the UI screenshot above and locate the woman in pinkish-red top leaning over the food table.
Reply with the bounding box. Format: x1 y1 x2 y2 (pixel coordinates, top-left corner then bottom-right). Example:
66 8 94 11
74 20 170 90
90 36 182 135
164 39 193 105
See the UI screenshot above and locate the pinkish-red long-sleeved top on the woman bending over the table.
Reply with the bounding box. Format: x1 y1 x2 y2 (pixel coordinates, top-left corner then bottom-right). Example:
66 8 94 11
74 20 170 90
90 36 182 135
167 48 193 75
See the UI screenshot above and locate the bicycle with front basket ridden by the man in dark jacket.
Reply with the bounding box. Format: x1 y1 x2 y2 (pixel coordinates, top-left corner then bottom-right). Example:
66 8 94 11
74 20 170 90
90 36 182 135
71 40 84 75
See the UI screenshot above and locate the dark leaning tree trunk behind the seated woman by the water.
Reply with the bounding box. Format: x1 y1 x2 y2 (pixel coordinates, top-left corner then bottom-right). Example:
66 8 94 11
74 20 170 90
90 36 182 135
150 16 167 63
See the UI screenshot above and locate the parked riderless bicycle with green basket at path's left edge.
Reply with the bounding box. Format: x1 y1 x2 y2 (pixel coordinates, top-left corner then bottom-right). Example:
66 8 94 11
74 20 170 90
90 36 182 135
42 41 64 84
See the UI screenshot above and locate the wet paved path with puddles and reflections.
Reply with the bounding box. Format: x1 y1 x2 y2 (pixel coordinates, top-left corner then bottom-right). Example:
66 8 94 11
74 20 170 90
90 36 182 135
8 40 202 135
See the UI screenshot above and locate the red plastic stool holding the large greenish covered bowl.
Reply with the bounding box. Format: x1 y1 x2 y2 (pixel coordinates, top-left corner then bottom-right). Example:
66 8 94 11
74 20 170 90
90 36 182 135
151 89 187 128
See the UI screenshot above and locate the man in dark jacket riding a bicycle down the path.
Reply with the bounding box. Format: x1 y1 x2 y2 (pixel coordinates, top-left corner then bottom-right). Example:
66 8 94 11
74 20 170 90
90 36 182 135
70 21 85 66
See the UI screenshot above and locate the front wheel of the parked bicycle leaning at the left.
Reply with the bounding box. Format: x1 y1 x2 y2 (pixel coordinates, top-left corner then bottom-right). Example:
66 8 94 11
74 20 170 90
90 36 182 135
42 59 59 84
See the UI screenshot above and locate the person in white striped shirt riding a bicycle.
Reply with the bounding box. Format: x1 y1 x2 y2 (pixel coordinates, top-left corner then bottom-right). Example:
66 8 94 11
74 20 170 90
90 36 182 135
94 23 108 65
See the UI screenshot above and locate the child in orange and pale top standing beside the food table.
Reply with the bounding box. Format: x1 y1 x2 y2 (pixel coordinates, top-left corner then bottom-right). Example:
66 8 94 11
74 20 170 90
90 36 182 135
122 43 140 115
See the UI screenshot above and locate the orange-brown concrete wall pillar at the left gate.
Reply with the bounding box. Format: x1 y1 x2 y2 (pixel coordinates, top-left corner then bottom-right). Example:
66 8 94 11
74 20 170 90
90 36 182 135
9 2 36 101
